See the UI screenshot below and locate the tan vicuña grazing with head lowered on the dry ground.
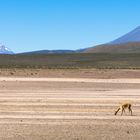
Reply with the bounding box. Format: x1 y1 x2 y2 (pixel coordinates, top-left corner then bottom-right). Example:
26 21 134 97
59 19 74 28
114 103 132 116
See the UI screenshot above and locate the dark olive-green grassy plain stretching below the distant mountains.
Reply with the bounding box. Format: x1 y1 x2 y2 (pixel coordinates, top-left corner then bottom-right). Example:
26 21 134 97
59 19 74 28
0 53 140 69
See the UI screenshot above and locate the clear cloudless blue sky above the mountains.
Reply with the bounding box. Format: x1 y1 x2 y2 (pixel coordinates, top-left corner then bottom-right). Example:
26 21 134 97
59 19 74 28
0 0 140 52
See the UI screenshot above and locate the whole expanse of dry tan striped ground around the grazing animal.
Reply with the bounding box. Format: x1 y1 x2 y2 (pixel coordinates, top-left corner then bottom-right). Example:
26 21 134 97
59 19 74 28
0 70 140 140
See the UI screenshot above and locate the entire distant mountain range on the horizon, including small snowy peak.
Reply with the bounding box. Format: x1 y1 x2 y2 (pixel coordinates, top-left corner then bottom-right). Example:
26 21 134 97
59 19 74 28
0 26 140 54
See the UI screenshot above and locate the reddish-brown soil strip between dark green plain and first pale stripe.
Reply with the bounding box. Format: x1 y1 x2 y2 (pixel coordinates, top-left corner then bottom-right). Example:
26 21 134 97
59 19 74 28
0 69 140 79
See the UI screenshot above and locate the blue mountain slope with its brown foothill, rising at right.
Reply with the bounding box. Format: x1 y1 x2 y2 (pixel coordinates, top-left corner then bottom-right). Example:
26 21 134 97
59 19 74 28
83 27 140 53
